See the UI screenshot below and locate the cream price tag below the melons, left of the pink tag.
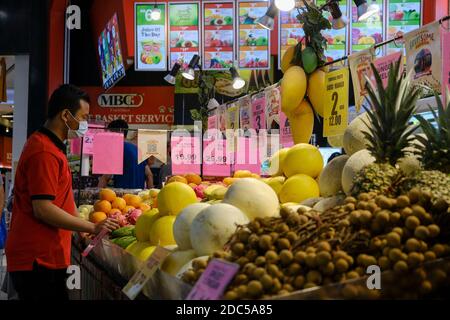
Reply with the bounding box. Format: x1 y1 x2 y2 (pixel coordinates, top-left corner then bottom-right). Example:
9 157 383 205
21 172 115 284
122 246 170 300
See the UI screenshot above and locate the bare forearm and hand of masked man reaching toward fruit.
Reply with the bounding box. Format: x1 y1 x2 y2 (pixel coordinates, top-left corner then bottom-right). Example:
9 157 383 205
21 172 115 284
32 200 119 234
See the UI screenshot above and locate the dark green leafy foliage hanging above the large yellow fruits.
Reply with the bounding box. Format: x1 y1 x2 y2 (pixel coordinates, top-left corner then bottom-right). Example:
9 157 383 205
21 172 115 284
297 0 331 65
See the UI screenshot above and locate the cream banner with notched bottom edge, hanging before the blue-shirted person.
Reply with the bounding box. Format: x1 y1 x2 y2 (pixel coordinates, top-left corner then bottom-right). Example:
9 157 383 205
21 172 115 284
138 129 167 164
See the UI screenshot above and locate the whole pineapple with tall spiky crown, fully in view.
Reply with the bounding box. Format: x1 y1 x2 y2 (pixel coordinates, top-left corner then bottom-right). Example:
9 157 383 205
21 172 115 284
353 59 420 195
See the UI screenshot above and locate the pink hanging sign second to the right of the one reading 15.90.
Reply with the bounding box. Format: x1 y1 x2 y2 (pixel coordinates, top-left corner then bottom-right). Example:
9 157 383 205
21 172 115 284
234 137 261 174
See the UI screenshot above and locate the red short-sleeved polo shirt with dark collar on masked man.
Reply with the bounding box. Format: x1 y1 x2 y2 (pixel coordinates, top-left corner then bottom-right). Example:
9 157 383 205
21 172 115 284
6 128 76 271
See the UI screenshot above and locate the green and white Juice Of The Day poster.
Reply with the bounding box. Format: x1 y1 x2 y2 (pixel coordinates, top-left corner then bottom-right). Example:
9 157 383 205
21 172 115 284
134 3 167 71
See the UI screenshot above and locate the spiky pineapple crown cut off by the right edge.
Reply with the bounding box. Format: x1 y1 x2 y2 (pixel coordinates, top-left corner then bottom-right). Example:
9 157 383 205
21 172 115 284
414 90 450 173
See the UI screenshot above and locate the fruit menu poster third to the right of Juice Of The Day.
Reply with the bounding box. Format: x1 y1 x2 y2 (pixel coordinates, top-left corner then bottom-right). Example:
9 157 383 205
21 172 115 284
238 1 270 69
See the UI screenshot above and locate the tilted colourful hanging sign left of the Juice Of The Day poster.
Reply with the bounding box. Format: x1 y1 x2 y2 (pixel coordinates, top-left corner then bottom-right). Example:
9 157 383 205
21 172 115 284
97 14 125 90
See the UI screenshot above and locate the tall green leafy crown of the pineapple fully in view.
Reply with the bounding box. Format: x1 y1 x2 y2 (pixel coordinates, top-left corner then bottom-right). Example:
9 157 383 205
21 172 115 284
363 58 421 166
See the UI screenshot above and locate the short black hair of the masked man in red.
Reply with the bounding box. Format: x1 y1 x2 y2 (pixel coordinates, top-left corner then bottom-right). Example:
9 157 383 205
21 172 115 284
47 84 90 119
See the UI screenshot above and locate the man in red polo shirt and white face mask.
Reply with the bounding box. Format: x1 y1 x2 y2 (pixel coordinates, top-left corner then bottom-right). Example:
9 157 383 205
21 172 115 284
6 85 118 301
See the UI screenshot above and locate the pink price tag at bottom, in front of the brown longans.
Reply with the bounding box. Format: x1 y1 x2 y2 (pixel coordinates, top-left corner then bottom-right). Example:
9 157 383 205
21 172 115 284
186 259 239 300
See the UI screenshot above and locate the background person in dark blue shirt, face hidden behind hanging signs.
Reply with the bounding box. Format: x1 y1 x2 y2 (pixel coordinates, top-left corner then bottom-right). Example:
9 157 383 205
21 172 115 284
98 119 146 189
